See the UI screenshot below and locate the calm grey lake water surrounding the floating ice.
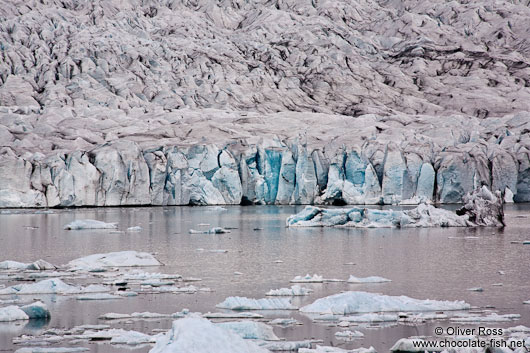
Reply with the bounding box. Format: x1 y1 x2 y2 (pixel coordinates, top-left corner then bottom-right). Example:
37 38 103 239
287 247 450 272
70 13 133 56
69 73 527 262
0 204 530 352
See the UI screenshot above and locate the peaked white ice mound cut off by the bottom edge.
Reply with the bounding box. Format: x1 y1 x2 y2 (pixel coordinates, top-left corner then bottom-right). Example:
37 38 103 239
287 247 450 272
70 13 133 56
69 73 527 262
149 318 269 353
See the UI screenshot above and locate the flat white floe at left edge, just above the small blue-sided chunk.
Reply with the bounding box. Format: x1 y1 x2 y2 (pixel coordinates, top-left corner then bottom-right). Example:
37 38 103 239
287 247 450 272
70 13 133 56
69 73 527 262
0 278 108 295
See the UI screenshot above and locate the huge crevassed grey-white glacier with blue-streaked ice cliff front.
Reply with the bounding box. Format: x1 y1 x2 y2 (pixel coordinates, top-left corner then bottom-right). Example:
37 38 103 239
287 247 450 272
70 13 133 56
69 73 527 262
0 0 530 207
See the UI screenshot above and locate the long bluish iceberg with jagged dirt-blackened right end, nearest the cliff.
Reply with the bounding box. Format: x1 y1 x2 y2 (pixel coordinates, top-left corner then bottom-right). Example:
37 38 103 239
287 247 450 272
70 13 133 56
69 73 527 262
286 186 504 228
